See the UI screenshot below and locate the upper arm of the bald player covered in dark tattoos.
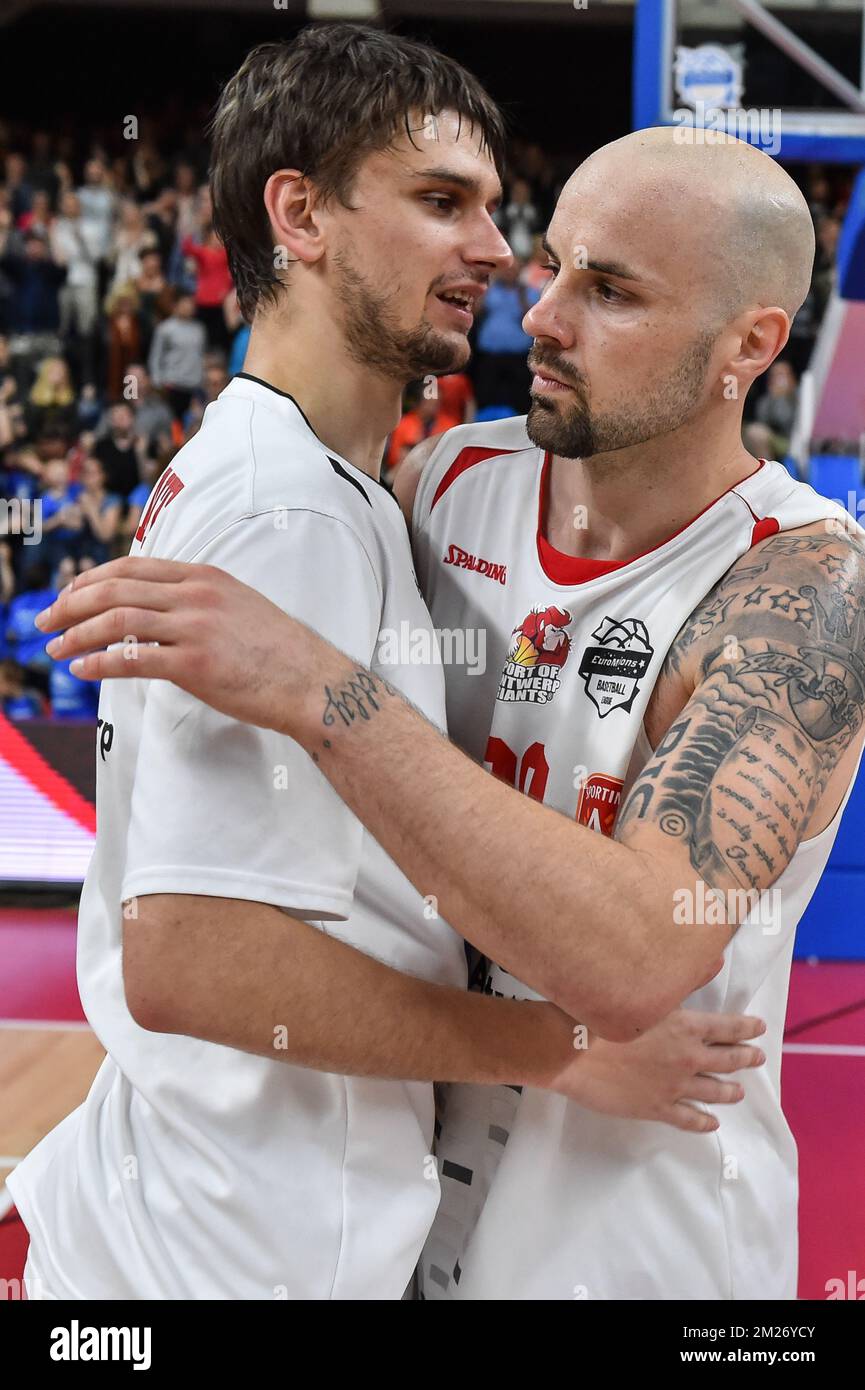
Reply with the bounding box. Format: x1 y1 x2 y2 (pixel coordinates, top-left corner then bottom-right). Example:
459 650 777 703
616 535 865 891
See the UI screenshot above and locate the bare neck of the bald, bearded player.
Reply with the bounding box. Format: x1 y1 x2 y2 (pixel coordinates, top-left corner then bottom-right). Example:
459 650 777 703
541 408 759 560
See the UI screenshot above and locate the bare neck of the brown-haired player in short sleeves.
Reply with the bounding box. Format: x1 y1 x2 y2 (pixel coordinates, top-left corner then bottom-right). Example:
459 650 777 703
243 311 403 478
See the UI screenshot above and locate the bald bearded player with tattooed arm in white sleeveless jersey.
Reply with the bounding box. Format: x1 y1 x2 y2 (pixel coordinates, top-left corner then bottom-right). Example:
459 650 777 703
35 131 865 1300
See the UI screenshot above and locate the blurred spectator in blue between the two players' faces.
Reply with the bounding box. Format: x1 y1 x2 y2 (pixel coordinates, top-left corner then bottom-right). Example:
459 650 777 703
474 260 541 416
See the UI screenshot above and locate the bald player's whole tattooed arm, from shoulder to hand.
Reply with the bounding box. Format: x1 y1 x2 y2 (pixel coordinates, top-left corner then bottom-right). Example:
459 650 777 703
33 535 865 1040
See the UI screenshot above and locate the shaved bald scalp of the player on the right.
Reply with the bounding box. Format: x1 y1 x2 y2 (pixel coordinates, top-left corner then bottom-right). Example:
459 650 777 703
560 126 814 318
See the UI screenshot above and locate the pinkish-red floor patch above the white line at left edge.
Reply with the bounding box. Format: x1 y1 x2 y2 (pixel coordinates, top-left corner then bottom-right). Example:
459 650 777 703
0 908 83 1023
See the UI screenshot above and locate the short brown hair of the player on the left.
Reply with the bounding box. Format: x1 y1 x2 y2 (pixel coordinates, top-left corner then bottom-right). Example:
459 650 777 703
210 24 505 321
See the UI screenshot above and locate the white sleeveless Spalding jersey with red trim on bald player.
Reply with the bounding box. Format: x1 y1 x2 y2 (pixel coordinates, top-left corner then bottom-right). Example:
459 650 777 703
413 418 850 1300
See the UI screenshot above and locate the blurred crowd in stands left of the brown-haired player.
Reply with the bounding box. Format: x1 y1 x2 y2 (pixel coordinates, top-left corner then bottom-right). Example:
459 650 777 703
0 129 249 719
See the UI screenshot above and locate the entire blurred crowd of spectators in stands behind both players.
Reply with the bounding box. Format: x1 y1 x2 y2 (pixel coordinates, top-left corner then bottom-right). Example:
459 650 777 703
0 124 850 719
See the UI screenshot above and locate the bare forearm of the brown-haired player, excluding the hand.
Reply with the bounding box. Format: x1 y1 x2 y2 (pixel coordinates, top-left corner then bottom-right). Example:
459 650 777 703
124 894 583 1087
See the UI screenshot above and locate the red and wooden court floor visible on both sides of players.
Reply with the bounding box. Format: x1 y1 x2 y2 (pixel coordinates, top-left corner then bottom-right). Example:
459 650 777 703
0 908 865 1300
